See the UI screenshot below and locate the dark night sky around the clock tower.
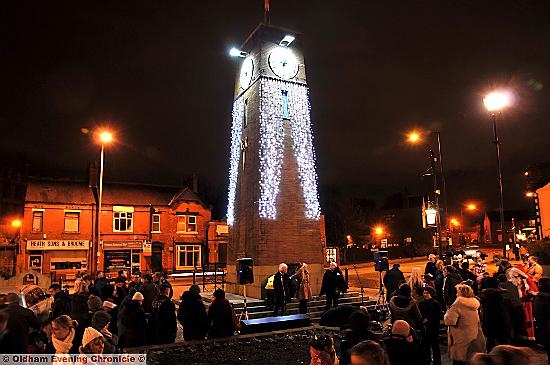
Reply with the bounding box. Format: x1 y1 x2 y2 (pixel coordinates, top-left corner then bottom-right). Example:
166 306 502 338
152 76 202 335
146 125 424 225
0 0 550 215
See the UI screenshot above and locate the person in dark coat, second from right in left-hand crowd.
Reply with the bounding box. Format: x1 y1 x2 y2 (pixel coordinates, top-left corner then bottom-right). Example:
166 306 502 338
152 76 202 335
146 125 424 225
178 284 209 341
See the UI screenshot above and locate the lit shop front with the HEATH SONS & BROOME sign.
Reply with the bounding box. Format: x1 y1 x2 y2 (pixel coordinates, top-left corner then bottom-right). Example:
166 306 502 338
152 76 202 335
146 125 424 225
26 240 90 281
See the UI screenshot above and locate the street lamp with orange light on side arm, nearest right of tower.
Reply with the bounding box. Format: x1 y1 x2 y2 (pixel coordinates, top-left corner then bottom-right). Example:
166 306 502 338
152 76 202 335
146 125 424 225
407 131 447 258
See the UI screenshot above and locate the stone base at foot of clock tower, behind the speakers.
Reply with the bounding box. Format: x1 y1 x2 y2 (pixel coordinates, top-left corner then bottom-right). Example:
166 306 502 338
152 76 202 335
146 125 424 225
225 264 325 299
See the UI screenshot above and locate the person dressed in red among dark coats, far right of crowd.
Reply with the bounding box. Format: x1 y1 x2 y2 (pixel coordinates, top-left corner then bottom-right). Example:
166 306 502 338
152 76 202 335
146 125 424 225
508 265 538 341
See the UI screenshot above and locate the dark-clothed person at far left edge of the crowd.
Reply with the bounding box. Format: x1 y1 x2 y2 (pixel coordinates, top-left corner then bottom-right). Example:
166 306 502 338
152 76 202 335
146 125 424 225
3 293 41 353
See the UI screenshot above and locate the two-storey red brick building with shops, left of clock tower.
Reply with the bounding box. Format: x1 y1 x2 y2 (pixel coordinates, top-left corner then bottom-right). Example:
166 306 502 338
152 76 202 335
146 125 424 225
17 179 227 279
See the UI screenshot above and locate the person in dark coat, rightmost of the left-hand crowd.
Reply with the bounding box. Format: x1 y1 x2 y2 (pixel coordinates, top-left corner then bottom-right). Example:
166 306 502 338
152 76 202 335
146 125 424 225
208 289 237 339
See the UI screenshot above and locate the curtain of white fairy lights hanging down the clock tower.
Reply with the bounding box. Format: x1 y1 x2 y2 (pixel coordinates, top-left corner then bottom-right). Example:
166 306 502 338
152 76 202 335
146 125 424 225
227 77 321 225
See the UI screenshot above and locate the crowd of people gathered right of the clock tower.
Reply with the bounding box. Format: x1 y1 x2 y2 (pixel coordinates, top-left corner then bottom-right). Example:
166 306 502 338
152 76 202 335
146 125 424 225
320 255 550 365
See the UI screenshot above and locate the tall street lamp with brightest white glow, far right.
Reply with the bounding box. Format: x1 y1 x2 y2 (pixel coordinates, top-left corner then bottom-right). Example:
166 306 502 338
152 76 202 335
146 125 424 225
483 91 512 257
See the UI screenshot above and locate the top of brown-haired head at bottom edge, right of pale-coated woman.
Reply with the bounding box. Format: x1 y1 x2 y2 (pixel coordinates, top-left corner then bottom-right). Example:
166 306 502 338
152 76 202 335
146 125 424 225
470 345 535 365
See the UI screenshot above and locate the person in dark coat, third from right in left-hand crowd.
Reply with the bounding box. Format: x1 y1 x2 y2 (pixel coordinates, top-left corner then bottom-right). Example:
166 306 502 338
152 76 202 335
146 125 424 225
149 284 178 344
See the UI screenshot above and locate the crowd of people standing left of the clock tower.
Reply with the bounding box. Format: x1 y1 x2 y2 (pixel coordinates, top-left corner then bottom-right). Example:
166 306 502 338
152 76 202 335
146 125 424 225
0 271 237 355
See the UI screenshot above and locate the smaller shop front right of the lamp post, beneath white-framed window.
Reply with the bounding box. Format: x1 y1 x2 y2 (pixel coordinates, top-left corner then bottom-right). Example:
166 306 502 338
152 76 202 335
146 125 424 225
103 241 146 277
